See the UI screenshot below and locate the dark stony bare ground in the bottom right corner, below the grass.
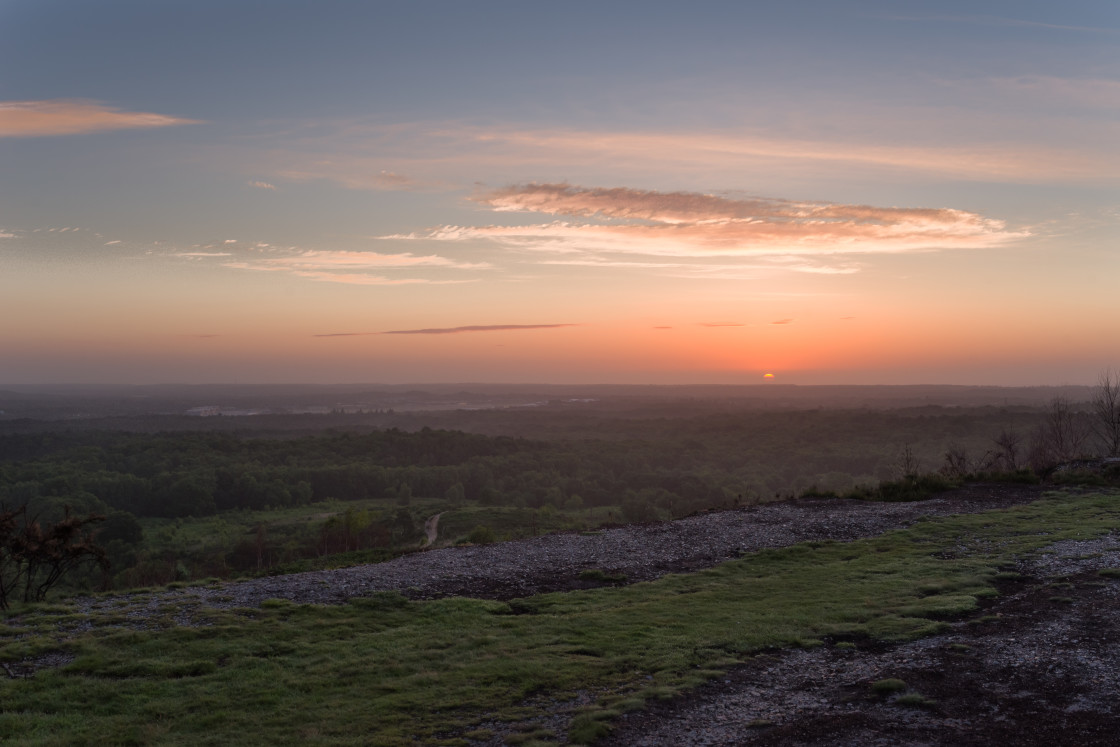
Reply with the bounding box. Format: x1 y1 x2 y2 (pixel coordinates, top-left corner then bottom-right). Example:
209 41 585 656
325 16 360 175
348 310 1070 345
603 534 1120 747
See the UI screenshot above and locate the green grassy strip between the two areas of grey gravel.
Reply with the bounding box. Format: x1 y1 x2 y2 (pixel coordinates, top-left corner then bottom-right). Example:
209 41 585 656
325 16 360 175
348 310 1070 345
0 493 1120 745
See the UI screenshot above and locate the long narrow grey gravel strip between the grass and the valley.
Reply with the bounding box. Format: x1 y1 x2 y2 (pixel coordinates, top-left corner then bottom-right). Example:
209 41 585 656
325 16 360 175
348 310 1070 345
84 485 1040 611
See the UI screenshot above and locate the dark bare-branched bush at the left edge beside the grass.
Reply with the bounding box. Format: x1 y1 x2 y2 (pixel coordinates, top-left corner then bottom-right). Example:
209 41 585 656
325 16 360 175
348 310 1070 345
0 505 109 609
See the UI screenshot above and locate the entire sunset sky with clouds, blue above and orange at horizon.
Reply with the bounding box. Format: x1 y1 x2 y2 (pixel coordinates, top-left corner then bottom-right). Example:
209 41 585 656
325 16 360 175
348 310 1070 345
0 0 1120 385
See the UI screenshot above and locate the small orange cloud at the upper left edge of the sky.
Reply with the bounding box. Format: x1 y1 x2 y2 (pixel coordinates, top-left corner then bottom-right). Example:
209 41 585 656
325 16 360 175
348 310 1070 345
0 99 200 138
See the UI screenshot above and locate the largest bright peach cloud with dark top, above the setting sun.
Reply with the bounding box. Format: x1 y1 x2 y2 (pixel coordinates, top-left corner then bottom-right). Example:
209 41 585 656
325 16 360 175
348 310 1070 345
384 184 1029 262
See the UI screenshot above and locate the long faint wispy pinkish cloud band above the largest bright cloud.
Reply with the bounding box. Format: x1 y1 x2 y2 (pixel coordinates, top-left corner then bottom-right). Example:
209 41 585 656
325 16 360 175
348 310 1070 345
231 110 1120 190
